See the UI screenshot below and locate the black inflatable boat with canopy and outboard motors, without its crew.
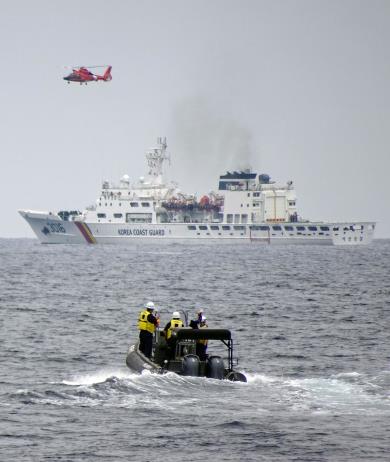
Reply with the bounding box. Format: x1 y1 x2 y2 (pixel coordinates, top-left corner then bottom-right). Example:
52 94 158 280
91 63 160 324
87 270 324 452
126 327 247 382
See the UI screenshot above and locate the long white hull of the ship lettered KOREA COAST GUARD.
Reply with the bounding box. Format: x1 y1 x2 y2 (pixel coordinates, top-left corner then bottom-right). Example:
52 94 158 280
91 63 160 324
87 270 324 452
19 210 375 245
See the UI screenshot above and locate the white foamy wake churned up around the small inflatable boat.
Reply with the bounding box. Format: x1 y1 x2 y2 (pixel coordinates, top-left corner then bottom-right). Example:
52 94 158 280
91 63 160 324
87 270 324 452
7 368 390 416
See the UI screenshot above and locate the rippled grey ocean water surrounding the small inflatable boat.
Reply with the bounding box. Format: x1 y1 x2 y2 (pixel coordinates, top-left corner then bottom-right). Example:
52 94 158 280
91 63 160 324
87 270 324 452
0 239 390 462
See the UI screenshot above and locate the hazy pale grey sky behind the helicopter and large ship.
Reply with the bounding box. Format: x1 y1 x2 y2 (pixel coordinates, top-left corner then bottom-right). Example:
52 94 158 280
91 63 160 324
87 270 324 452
0 0 390 237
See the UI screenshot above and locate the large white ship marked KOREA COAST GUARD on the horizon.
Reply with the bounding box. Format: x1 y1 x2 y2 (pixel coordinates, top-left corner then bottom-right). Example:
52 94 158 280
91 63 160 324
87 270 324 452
19 138 375 245
